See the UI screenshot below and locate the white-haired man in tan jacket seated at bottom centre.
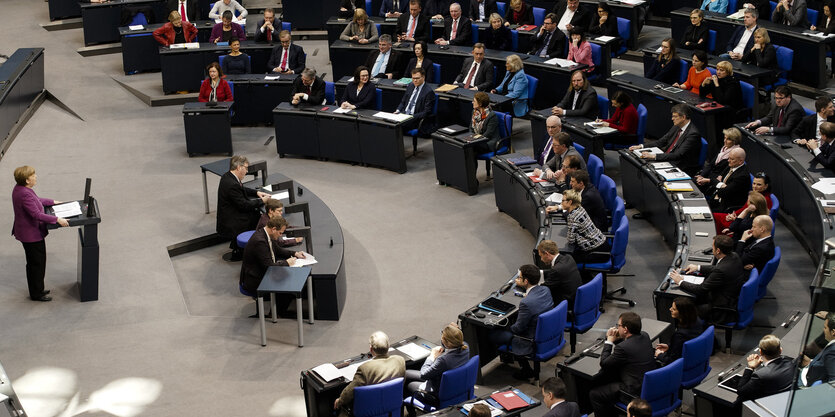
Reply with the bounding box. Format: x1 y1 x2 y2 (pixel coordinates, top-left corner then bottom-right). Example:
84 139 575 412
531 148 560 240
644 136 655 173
333 331 406 417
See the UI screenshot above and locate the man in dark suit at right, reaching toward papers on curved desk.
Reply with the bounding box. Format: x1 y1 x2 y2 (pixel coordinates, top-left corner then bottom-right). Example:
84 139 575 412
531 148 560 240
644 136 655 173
670 235 746 323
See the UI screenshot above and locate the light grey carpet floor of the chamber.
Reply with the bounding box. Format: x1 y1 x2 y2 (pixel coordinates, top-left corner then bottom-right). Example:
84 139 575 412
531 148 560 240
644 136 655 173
0 1 814 417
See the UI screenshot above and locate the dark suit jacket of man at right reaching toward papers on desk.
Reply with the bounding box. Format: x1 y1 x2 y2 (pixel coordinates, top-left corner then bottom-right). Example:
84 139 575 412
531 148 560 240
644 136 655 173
679 253 745 309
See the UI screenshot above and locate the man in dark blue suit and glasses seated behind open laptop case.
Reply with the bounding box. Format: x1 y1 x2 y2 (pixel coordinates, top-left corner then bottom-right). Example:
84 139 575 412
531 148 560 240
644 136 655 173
490 265 554 380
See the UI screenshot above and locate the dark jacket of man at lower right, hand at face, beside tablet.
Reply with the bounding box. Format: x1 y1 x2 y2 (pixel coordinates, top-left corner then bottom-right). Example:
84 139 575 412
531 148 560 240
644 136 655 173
736 356 796 403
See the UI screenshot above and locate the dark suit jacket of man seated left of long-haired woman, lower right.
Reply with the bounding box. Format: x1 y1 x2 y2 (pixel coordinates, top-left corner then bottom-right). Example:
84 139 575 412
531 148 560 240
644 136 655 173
600 332 656 395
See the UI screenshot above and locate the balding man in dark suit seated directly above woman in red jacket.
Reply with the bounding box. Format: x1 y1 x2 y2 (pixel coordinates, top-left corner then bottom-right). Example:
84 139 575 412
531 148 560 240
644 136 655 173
699 148 751 213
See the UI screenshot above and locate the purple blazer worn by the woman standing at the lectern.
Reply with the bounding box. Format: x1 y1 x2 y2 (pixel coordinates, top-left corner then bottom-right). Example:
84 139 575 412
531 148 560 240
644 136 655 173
12 185 58 243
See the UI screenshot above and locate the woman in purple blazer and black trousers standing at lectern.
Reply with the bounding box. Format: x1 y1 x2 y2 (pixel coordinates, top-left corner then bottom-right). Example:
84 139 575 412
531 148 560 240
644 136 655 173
12 165 70 301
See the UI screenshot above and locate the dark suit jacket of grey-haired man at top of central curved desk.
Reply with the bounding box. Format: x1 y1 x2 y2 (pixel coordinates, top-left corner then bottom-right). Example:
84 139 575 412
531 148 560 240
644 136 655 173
216 171 264 239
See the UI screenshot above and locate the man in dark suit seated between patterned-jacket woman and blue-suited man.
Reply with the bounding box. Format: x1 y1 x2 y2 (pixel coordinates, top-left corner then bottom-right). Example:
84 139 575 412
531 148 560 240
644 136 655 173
536 240 583 310
